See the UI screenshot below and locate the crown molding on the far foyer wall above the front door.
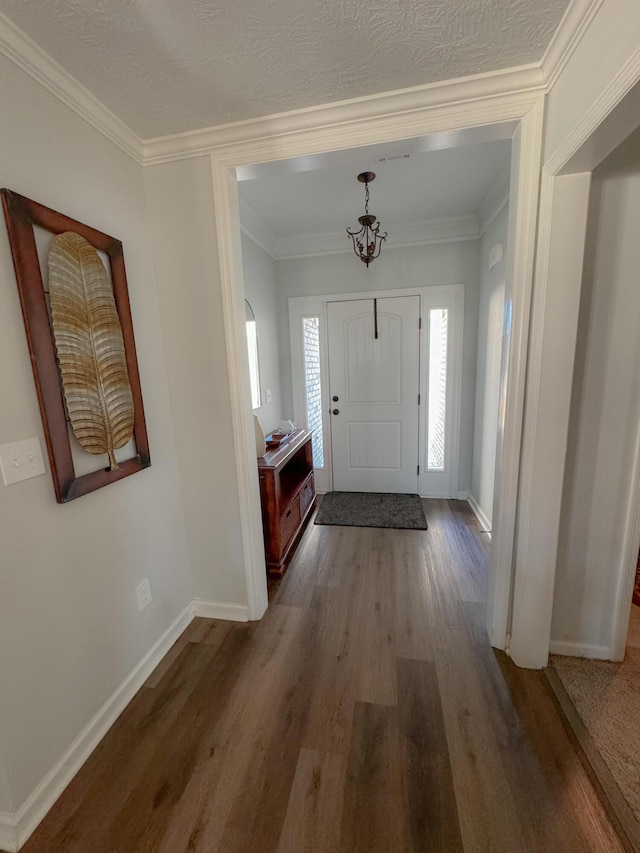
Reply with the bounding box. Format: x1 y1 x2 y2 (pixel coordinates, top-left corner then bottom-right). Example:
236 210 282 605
275 213 480 261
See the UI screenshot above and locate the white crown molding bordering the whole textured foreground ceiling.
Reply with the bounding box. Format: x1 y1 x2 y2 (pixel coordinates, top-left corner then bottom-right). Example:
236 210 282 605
0 0 603 165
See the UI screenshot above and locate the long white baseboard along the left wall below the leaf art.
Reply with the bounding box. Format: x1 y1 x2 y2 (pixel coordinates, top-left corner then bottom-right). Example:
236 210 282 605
6 603 195 853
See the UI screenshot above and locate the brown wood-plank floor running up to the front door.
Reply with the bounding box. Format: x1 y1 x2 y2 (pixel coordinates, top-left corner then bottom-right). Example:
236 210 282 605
17 501 623 853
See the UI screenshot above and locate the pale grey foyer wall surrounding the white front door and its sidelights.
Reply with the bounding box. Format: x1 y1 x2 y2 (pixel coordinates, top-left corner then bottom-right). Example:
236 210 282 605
276 240 479 492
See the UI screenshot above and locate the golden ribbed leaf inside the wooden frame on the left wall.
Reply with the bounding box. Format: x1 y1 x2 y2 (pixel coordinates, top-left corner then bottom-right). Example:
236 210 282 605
49 231 134 470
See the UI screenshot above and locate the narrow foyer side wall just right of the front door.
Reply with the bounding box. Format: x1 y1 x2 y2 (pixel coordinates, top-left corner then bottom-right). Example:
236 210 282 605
471 205 509 529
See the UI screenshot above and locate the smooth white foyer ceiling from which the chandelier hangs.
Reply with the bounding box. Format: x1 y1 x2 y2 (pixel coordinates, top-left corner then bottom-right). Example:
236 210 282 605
238 131 511 254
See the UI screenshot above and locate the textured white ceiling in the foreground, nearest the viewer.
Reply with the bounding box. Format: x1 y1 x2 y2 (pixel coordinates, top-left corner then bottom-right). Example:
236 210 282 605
0 0 568 139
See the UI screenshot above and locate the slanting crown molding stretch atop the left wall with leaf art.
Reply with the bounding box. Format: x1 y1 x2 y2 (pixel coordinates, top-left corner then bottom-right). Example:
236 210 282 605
0 12 144 164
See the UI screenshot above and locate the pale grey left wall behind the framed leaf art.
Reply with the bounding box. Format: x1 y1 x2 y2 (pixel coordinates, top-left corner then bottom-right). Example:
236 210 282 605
0 58 192 812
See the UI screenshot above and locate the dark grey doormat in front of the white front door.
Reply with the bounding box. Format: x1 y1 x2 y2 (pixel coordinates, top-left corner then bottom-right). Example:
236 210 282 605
315 492 427 530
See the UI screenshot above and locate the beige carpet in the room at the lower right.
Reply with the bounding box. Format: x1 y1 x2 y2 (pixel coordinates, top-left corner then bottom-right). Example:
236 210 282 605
551 628 640 821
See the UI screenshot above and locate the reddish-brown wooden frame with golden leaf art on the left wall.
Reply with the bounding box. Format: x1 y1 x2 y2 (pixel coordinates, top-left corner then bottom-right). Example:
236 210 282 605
0 189 151 503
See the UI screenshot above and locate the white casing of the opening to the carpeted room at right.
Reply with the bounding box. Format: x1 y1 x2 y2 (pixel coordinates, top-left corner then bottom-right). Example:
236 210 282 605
510 56 640 667
